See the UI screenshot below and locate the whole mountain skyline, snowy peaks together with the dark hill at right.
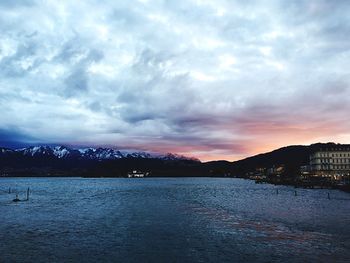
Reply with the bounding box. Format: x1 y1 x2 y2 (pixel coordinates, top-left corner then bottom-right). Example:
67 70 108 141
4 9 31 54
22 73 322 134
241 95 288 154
0 143 350 177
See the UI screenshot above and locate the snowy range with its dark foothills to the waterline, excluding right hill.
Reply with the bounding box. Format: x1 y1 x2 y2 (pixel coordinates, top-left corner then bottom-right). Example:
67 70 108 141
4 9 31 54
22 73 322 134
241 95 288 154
0 145 201 177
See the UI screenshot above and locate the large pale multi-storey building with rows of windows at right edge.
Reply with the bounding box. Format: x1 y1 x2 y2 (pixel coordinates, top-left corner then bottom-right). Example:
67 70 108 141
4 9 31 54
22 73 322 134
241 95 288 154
310 144 350 177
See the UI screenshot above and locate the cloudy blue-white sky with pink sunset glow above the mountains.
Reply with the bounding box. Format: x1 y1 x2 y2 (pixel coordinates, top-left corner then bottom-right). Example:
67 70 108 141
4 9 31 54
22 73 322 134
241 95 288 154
0 0 350 161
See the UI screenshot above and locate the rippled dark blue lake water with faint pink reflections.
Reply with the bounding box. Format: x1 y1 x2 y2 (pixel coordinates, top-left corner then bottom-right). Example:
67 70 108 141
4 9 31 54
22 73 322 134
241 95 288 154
0 178 350 262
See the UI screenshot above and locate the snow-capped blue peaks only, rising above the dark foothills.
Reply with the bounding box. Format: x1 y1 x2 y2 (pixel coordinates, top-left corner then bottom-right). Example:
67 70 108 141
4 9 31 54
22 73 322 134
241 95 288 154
0 145 198 161
